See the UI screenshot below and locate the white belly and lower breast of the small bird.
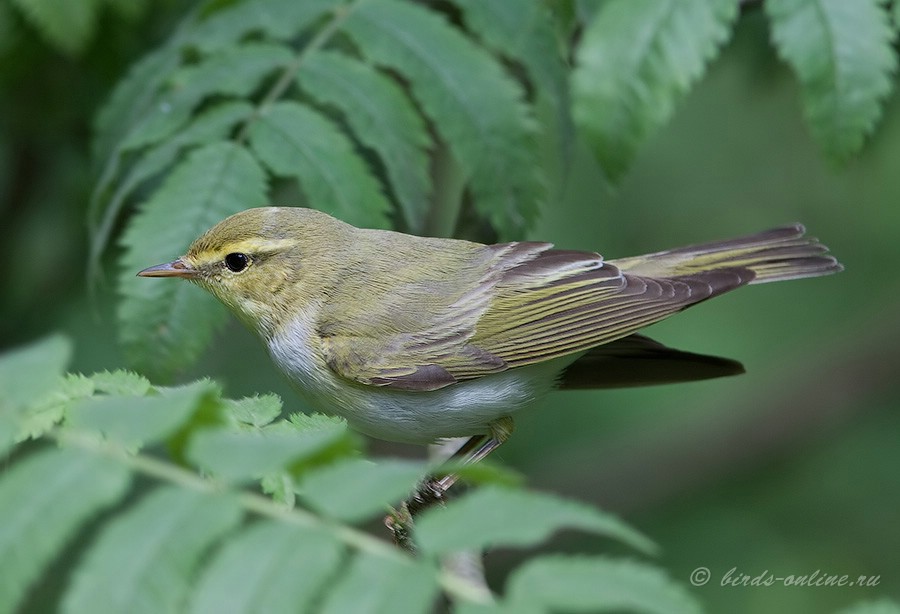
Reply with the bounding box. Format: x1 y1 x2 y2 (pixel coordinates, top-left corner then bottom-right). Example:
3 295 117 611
269 316 576 443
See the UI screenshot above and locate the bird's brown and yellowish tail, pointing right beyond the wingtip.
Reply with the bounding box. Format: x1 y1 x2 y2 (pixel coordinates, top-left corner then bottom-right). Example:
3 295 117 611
610 224 844 284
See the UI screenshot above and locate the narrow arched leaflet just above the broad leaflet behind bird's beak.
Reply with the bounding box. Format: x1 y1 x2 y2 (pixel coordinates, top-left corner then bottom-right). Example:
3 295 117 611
89 101 253 277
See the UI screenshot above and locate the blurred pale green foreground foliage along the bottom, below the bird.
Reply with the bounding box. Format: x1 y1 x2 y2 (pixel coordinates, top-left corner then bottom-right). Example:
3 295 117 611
0 338 698 612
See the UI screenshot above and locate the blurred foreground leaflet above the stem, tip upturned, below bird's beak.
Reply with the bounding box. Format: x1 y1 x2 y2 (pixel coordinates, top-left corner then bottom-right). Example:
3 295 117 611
68 381 218 446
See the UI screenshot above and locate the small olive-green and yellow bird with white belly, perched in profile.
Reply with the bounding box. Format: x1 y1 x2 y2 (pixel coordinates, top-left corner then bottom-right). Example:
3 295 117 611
138 207 842 460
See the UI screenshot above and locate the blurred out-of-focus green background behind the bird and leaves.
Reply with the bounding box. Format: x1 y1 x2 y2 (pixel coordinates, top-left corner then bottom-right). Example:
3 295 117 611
0 2 900 612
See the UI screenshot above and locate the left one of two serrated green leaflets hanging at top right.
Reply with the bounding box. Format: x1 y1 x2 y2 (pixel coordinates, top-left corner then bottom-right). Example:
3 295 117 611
572 0 738 181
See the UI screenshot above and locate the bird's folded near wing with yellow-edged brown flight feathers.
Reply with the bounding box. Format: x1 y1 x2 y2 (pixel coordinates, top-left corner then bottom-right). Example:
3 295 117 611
320 243 753 390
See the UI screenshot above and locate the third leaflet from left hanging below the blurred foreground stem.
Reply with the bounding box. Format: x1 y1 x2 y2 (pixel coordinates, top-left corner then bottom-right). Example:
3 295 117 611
189 522 343 614
